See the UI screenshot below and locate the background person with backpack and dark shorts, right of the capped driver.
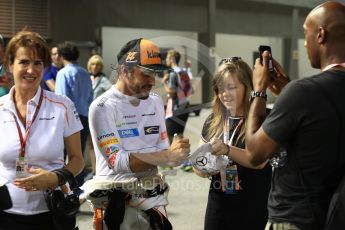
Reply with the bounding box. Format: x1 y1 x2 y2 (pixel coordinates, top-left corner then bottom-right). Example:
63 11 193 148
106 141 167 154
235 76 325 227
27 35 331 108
162 50 193 172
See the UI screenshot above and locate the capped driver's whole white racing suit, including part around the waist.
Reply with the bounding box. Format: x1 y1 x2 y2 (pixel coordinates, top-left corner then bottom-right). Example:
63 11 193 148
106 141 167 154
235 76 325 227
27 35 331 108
87 87 169 230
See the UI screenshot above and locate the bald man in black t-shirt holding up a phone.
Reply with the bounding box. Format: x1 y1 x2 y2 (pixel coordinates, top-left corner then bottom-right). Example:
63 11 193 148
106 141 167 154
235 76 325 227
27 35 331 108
236 2 345 230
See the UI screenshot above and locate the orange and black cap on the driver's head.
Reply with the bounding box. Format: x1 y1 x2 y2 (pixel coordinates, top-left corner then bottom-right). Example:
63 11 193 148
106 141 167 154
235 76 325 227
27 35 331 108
117 38 169 72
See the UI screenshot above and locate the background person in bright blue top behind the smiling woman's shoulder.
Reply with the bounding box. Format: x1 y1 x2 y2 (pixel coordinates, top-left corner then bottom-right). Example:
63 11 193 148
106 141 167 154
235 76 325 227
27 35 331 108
43 46 62 92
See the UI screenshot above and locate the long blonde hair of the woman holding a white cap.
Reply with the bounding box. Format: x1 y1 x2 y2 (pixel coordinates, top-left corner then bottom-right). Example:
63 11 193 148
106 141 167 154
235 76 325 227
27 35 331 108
207 60 253 143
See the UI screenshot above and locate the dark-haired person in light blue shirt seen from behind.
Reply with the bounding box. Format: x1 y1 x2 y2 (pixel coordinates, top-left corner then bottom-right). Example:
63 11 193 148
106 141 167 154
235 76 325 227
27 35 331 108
55 42 93 189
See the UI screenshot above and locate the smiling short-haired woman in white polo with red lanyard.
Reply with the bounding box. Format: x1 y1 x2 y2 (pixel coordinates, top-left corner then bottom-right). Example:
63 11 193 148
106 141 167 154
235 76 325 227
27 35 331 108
0 31 84 230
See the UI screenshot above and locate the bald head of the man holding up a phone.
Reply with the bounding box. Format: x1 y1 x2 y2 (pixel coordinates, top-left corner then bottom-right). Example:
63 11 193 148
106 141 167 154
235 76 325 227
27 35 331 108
303 2 345 69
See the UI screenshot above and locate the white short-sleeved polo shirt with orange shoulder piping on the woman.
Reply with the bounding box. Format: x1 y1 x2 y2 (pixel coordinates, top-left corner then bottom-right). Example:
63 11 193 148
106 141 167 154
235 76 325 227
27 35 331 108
0 88 83 215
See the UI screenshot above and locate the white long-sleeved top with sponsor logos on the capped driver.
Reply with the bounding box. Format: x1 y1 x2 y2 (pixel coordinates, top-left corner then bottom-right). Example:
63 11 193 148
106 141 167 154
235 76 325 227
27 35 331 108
89 87 169 180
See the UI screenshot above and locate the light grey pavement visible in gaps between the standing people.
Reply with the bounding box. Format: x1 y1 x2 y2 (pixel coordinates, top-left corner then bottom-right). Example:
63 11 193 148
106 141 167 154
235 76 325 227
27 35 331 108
77 108 211 230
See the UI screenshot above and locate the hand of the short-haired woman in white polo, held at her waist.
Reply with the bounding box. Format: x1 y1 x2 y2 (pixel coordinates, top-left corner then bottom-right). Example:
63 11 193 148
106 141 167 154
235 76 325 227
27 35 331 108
14 168 58 191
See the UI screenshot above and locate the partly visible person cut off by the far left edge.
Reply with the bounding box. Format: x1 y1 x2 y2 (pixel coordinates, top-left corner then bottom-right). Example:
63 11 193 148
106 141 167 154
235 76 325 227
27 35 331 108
0 34 13 97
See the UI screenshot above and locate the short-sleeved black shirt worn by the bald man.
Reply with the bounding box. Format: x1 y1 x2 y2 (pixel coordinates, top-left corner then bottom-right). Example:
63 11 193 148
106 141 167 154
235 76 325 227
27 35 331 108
262 71 345 229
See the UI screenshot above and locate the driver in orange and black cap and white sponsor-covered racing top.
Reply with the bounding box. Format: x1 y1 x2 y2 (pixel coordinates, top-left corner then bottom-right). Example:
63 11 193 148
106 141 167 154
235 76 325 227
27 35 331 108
83 38 190 229
